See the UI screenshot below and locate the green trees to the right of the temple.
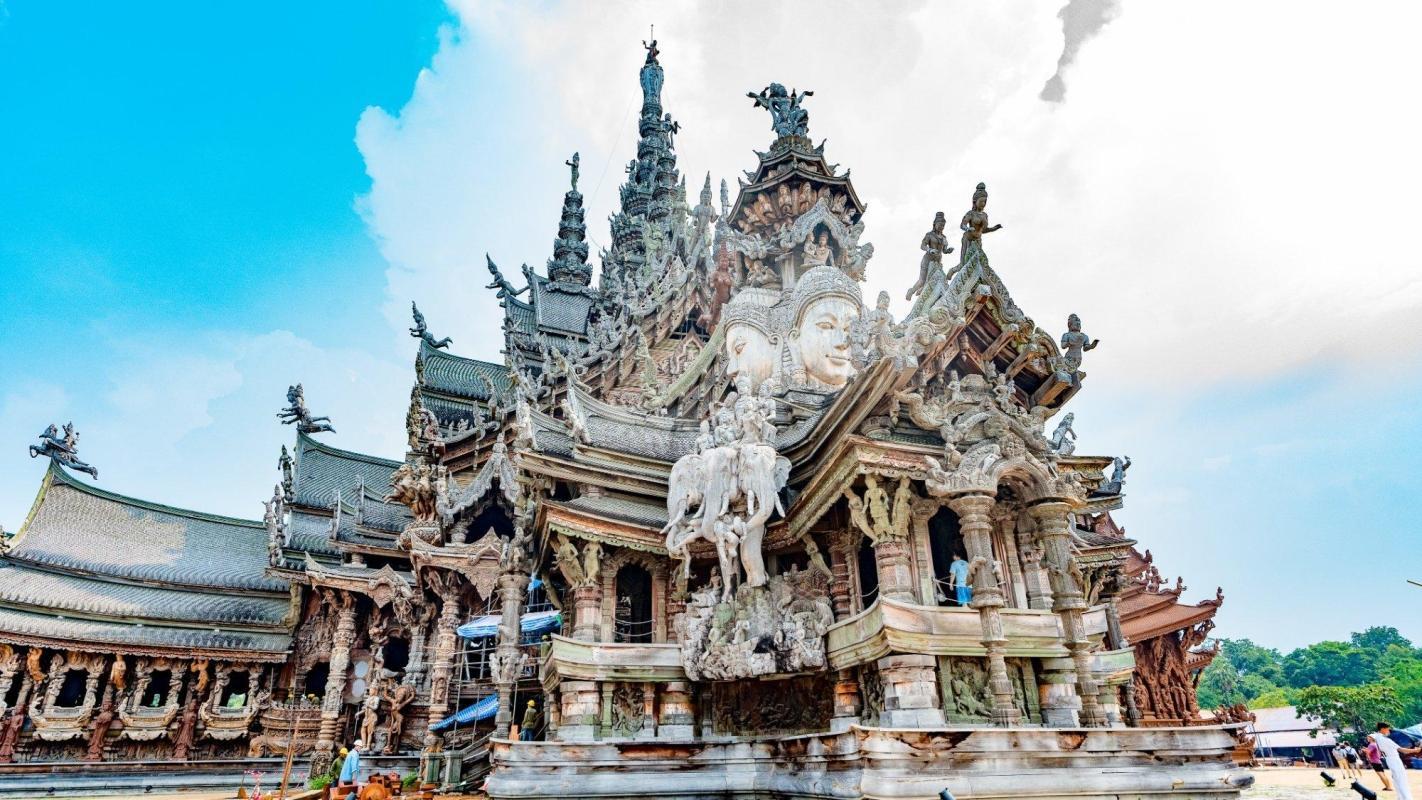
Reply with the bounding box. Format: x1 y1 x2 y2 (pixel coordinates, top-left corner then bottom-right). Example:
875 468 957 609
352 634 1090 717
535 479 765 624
1199 627 1422 730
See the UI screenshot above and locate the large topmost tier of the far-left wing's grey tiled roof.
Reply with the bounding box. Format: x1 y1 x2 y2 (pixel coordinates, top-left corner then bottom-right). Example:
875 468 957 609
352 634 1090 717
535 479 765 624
9 467 286 591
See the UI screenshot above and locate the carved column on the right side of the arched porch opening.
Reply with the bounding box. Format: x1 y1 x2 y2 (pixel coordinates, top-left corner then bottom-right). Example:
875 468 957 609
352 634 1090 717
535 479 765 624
1032 500 1106 728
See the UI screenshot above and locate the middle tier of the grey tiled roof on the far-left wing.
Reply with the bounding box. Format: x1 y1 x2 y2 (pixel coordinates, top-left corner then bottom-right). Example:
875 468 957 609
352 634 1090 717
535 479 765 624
0 563 290 625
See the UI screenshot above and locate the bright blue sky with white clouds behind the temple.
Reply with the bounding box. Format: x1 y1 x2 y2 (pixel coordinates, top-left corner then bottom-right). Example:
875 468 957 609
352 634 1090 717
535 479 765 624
0 0 1422 647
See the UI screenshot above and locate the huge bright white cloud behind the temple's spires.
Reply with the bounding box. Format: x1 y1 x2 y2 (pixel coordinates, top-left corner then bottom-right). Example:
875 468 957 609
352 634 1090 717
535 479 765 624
360 0 1422 391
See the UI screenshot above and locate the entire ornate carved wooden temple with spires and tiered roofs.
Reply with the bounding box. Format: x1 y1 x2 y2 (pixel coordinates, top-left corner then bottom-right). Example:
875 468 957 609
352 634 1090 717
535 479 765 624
0 43 1247 799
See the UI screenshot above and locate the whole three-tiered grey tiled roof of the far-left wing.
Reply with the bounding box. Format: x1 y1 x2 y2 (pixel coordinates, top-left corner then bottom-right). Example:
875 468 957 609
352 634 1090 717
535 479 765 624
0 466 296 661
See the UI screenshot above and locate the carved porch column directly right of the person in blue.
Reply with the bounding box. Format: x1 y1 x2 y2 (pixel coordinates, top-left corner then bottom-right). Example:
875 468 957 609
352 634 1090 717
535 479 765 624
948 494 1021 726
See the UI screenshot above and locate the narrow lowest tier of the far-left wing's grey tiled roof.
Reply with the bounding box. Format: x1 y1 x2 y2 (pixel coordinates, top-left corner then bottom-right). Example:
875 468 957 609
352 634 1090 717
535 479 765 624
0 608 292 654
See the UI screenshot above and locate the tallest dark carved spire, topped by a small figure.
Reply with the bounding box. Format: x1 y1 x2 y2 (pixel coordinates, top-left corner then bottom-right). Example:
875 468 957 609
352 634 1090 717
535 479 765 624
603 40 681 291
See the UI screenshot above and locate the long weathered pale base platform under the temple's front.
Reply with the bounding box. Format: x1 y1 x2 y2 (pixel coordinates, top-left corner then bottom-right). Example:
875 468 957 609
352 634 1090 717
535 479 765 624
485 726 1253 800
